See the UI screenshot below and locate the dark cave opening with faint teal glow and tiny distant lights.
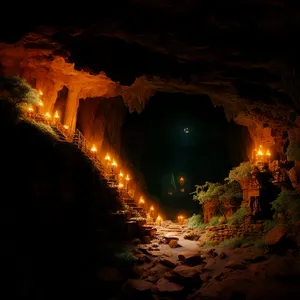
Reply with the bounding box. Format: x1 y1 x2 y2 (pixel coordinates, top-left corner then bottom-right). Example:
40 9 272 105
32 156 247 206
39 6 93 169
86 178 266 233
121 93 251 219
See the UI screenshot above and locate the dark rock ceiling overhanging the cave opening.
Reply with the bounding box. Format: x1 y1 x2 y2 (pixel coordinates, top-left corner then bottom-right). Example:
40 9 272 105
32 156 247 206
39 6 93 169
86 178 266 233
0 0 300 131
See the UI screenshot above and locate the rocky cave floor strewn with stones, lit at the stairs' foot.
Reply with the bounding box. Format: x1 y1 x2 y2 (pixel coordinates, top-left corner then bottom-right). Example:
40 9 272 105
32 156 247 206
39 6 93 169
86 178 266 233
103 222 300 300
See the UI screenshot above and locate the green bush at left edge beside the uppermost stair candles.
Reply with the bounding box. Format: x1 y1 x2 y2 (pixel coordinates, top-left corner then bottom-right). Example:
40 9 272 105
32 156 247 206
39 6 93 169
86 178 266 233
0 76 39 104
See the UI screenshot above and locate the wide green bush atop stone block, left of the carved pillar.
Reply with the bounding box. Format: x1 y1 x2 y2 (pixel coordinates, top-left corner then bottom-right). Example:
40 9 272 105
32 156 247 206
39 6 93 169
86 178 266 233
192 181 243 204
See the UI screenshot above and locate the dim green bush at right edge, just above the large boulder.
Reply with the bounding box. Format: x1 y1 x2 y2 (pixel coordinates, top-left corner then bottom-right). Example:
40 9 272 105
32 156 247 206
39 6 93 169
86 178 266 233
272 190 300 222
